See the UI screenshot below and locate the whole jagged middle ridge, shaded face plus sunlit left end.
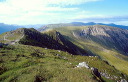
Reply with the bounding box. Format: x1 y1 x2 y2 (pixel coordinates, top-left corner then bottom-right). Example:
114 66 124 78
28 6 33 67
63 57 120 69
0 28 87 55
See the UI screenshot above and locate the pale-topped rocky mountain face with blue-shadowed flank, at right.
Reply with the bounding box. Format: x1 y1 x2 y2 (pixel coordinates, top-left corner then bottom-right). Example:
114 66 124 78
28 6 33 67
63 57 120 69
75 25 128 55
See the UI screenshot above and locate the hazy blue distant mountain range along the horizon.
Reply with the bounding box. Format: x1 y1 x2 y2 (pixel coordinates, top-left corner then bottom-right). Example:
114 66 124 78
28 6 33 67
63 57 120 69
0 22 128 34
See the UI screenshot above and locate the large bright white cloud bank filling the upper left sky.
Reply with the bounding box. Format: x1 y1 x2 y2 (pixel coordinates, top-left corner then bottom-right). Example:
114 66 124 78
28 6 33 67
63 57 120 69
0 0 100 24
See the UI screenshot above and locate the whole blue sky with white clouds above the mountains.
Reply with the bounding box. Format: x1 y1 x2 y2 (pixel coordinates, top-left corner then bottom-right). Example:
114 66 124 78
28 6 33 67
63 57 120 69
0 0 128 26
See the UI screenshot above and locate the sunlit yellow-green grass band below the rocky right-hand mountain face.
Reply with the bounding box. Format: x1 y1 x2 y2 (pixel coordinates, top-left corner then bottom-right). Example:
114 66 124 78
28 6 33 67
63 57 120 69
56 26 128 75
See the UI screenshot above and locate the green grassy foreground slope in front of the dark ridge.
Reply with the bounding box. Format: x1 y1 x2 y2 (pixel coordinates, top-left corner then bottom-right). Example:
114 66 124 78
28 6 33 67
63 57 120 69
0 45 126 82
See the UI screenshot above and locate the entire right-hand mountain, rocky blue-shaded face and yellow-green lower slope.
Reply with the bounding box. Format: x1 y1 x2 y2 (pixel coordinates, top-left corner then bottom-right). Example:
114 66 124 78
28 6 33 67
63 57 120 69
56 25 128 74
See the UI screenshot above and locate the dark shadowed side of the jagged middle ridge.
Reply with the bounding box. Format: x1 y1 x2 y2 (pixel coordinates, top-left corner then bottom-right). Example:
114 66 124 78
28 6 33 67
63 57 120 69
19 29 87 55
